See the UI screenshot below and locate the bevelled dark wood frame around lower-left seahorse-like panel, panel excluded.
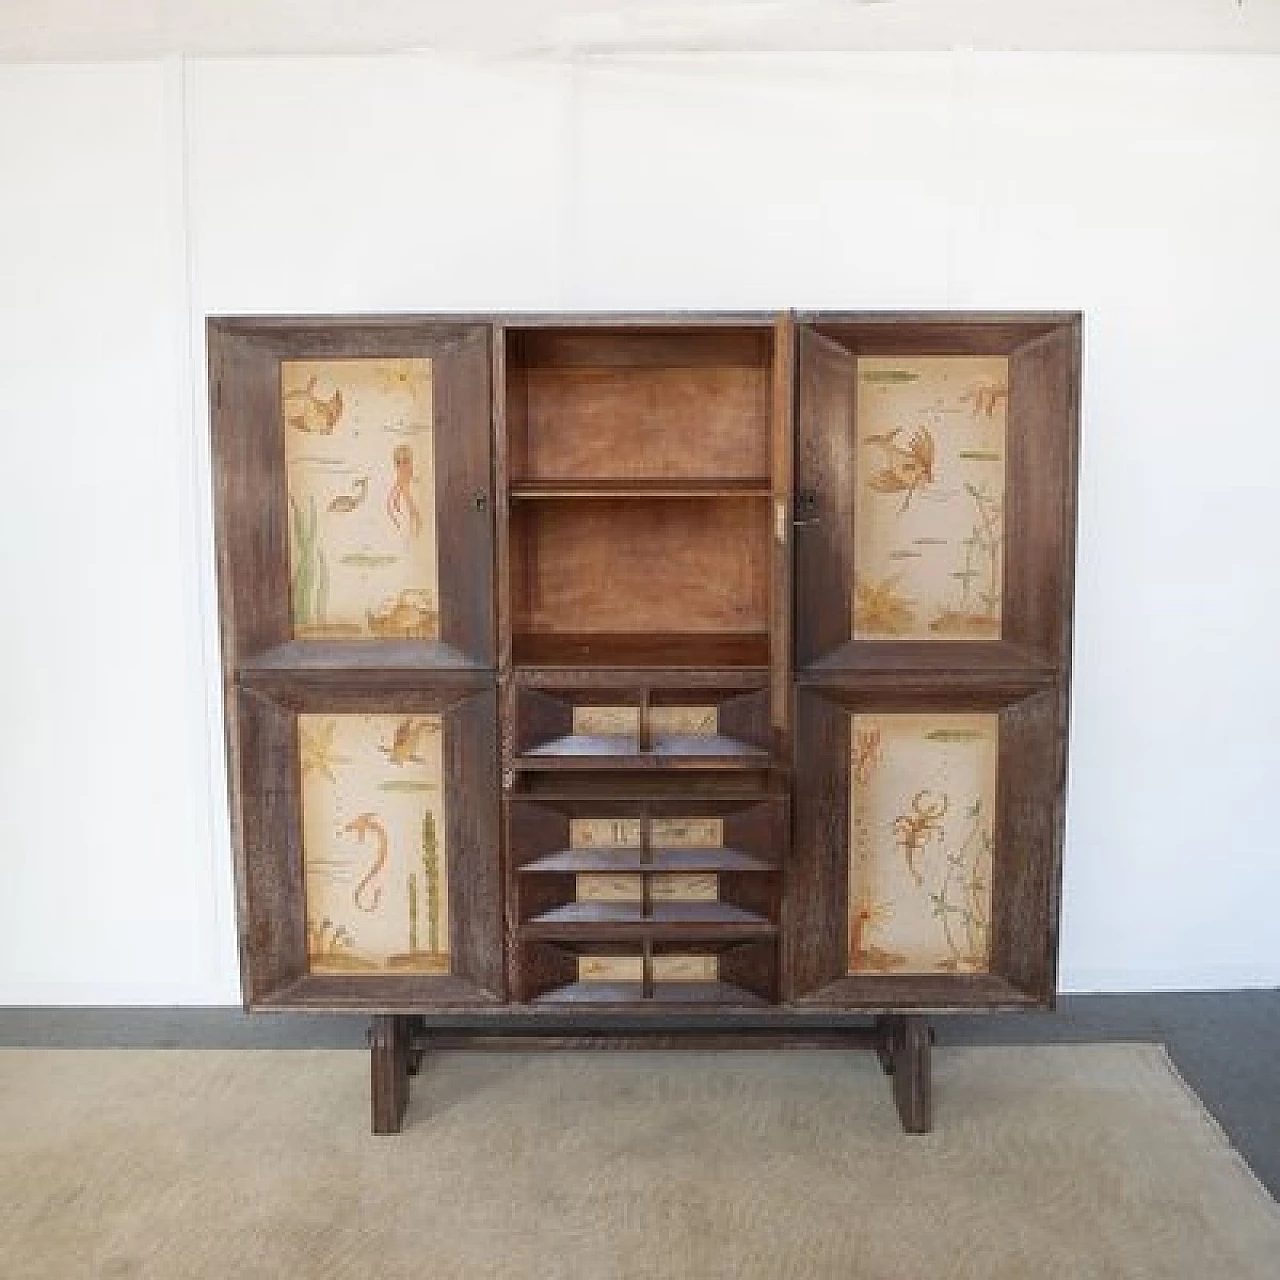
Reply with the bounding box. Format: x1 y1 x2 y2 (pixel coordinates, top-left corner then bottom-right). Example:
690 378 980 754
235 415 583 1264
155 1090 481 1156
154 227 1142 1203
233 677 506 1012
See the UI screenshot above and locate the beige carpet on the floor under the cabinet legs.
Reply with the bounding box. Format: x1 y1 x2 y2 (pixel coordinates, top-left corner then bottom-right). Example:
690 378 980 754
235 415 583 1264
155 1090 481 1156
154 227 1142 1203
0 1044 1280 1280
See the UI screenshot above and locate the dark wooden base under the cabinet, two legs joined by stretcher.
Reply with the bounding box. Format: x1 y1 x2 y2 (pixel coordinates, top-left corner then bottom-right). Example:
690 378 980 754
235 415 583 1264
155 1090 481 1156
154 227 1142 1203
369 1014 933 1134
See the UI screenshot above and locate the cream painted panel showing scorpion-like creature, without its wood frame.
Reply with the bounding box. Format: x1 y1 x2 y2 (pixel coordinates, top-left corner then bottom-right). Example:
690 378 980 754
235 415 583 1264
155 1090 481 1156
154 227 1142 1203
849 713 1000 973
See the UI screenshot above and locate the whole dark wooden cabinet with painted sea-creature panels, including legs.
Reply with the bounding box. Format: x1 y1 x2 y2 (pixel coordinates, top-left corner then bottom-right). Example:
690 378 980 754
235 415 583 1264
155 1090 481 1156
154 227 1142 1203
209 312 1080 1132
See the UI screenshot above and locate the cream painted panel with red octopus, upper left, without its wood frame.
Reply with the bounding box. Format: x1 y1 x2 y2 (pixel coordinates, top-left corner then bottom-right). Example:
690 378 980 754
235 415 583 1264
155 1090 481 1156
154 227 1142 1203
280 358 439 640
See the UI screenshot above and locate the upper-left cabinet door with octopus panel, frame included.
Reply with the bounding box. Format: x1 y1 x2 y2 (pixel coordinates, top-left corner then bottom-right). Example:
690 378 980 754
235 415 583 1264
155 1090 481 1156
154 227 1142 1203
209 317 494 668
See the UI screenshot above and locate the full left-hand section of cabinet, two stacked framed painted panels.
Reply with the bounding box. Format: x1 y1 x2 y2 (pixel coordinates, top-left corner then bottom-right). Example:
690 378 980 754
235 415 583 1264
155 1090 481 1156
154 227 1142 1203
209 316 506 1010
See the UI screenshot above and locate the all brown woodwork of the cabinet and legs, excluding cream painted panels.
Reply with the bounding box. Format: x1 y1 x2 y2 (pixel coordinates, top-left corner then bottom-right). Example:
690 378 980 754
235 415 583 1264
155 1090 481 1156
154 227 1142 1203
209 312 1080 1133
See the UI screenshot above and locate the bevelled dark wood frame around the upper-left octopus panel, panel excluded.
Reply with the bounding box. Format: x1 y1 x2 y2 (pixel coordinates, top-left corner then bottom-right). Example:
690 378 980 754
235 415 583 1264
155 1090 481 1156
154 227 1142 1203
207 316 494 677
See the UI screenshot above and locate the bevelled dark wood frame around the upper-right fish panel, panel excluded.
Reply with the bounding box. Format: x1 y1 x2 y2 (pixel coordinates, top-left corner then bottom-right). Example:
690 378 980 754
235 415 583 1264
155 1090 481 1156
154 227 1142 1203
795 312 1080 677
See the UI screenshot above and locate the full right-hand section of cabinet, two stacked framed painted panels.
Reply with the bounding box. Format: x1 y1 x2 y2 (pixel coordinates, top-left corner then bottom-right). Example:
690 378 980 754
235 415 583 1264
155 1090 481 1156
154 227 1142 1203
783 314 1080 1010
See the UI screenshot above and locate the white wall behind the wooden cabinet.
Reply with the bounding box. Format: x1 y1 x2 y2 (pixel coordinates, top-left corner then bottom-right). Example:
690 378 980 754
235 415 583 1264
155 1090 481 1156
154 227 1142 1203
0 54 1280 1004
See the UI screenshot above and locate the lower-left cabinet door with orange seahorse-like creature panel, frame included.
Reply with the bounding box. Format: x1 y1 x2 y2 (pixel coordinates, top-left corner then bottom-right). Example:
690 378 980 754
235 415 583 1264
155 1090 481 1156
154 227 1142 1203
236 673 504 1010
